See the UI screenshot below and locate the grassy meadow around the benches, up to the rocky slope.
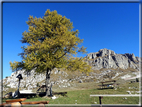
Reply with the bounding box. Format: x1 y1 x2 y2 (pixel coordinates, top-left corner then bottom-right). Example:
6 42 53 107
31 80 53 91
3 81 139 104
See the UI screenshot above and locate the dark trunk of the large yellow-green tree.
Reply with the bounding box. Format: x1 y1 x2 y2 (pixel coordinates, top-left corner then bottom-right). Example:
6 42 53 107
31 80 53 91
45 68 52 96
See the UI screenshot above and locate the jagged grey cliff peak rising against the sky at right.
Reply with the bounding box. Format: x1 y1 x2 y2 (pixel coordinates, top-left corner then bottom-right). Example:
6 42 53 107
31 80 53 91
86 48 140 71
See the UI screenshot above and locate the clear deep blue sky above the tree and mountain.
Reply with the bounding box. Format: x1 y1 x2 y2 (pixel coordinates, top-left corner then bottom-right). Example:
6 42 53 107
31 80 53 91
3 3 139 78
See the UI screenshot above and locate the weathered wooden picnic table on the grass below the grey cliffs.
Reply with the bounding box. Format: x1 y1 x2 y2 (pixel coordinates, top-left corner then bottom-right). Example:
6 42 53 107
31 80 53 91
98 80 119 89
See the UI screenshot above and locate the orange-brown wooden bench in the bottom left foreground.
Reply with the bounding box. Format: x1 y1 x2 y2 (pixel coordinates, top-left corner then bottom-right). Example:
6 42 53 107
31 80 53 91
0 98 49 107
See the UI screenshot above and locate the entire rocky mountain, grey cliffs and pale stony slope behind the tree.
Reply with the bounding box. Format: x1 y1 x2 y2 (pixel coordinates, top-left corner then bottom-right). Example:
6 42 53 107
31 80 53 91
0 49 141 91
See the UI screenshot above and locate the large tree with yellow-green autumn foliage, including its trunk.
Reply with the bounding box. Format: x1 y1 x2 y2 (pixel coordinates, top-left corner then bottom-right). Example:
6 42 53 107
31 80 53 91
10 10 91 96
